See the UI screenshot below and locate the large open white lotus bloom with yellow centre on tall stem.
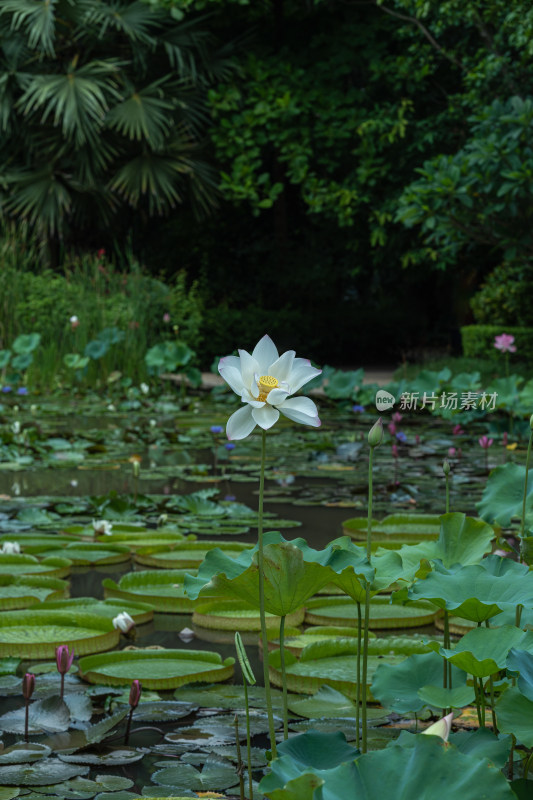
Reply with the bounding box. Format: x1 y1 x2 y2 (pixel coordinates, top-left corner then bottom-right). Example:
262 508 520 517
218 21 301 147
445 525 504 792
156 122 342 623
218 336 322 439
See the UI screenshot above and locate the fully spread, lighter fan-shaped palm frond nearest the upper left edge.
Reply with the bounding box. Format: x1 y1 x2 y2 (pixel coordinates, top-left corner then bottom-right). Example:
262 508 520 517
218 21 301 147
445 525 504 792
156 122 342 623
17 61 120 146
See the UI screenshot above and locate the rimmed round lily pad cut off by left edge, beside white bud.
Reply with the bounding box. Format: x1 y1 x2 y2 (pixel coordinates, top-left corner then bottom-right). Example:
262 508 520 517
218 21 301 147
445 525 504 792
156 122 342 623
0 609 120 659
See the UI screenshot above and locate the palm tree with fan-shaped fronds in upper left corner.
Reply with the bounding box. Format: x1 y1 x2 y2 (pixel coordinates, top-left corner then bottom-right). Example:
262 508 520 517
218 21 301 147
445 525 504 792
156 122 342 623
0 0 231 255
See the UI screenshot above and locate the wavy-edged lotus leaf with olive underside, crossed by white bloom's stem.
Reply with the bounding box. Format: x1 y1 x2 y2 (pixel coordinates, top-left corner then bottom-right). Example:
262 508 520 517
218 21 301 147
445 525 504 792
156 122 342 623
185 532 373 616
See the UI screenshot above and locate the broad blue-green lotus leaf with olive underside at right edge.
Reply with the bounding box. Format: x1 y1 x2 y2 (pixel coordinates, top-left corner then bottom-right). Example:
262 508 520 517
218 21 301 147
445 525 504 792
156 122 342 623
408 556 533 622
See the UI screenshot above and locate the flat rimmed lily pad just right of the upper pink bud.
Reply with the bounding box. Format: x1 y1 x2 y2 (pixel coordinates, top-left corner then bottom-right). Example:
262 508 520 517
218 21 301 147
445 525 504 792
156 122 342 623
79 650 235 689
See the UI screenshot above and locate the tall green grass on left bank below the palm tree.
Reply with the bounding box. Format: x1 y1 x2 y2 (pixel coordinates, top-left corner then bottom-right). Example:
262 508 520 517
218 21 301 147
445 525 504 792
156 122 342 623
0 227 201 391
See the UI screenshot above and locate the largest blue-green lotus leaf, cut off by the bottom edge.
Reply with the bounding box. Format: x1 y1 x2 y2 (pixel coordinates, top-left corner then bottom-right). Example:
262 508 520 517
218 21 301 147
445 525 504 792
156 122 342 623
259 735 513 800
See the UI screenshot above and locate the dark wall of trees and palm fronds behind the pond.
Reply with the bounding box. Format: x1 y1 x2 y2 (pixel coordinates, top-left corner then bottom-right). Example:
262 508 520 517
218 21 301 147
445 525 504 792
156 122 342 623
0 0 533 363
